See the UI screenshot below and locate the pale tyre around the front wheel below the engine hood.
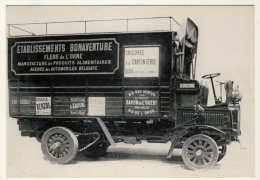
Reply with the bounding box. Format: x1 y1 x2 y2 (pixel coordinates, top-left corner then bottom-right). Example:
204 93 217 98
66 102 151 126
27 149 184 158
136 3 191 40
182 134 219 170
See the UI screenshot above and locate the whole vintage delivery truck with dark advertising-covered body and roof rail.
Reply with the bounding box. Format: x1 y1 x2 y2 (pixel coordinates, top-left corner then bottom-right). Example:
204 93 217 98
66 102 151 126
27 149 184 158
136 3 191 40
8 18 242 170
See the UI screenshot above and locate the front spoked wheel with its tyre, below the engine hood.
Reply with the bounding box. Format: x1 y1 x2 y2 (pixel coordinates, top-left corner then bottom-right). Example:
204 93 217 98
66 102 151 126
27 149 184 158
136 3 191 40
182 134 219 170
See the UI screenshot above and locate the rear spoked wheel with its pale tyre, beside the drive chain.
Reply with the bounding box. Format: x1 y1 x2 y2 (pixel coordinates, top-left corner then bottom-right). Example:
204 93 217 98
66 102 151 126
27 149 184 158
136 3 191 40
41 127 79 164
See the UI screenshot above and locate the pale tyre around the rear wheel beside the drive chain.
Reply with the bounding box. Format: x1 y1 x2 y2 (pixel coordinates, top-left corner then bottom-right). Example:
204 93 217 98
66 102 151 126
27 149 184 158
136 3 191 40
41 127 79 164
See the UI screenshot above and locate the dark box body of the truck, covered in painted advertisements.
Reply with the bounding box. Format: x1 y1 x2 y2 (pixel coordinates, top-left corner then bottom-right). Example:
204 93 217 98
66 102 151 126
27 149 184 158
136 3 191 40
8 31 176 119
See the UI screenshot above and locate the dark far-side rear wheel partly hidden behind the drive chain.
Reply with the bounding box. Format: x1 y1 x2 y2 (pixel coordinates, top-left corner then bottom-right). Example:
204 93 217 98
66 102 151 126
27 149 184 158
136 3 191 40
82 142 108 157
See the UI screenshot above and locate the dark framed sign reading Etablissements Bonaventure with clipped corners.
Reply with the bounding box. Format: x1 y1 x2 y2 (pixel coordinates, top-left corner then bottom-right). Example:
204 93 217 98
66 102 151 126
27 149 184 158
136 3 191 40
11 38 119 75
